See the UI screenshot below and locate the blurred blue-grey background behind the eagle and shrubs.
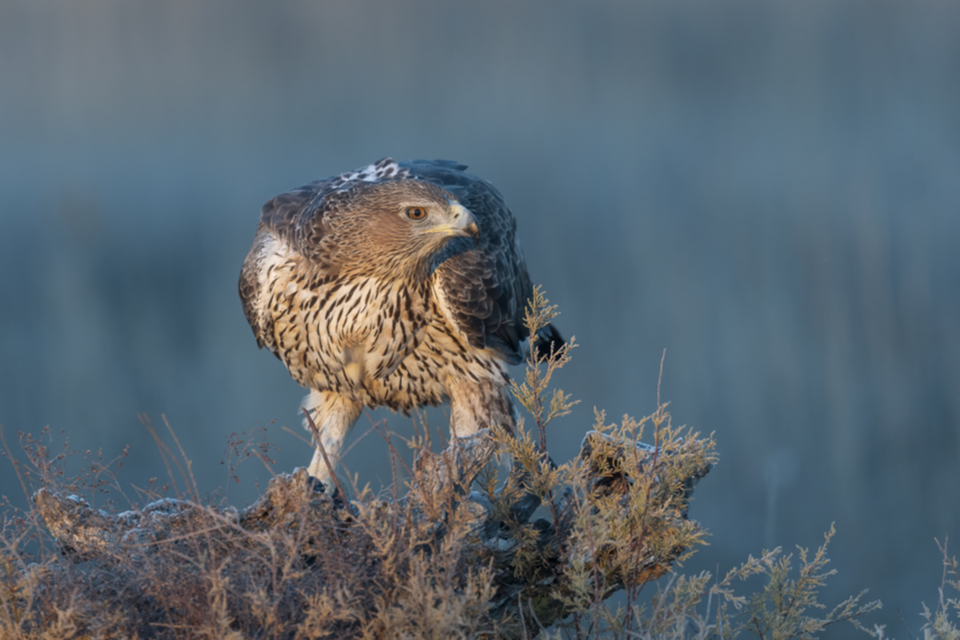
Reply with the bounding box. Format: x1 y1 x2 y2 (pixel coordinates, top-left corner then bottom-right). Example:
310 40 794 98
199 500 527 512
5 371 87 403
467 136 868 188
0 0 960 637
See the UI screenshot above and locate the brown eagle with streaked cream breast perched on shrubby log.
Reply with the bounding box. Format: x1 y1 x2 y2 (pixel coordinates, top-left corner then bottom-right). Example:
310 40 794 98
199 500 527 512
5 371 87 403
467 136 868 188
240 158 562 484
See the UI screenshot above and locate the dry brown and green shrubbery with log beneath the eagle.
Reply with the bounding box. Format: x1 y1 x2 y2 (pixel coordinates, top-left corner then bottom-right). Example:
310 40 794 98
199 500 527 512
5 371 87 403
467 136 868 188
0 289 900 640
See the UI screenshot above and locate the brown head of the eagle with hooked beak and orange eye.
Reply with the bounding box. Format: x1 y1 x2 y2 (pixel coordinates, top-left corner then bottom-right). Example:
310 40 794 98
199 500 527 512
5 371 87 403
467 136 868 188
343 179 479 274
